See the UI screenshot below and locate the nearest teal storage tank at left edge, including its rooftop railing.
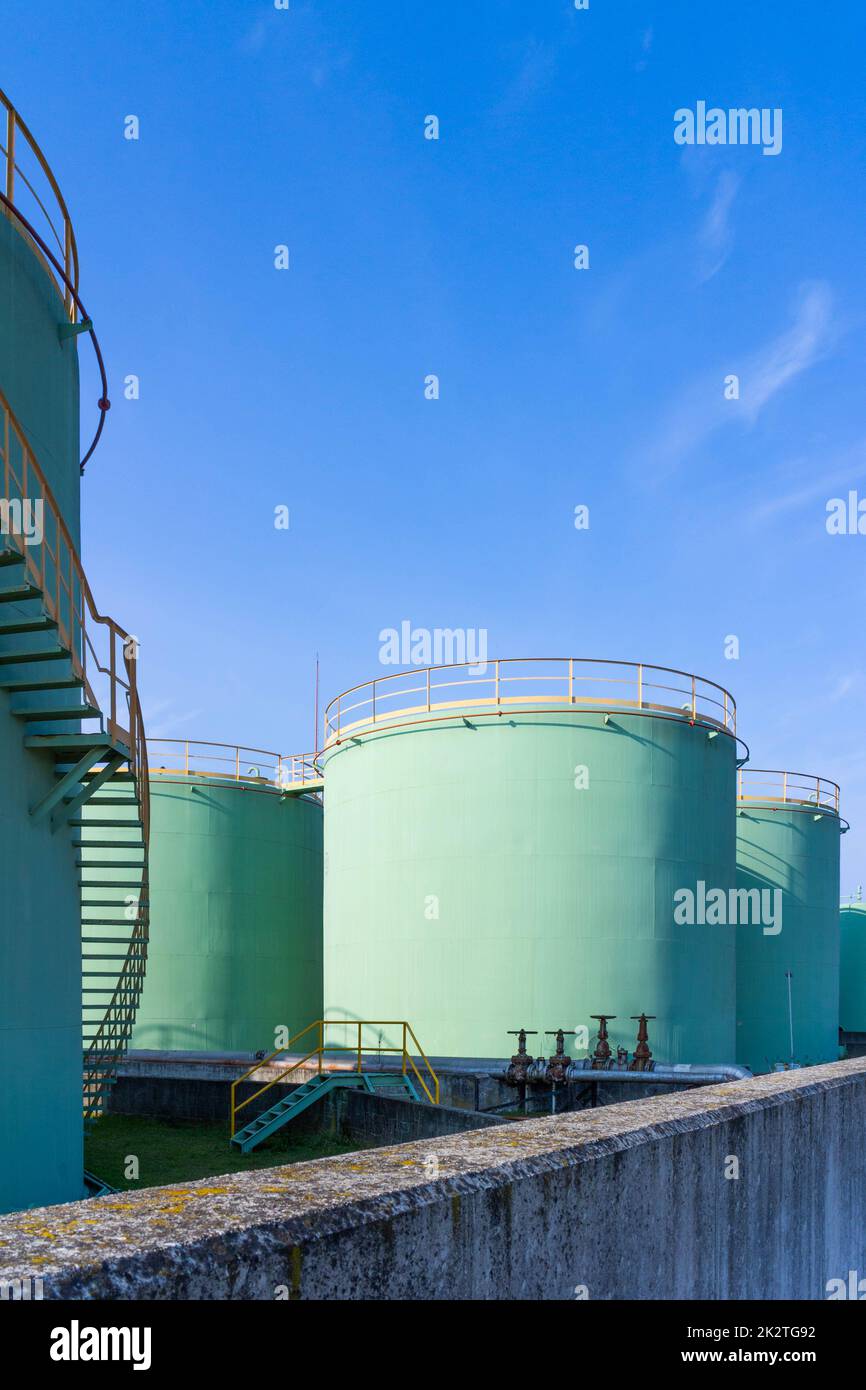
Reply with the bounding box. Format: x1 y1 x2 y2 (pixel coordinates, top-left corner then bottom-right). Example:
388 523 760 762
0 92 84 1212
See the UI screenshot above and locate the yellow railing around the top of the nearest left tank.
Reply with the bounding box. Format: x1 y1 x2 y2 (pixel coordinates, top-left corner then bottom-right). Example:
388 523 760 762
0 90 78 322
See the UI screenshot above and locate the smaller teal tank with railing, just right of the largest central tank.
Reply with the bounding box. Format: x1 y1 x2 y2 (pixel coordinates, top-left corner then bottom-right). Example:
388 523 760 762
737 767 842 1072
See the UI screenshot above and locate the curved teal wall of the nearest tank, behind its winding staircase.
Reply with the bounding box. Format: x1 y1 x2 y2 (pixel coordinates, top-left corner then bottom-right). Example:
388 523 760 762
0 217 82 1211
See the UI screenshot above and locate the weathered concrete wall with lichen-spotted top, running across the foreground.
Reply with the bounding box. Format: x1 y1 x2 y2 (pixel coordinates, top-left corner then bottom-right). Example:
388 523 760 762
0 1061 866 1300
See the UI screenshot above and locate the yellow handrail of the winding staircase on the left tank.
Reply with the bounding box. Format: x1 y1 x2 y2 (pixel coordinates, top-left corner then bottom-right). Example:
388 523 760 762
0 391 150 1119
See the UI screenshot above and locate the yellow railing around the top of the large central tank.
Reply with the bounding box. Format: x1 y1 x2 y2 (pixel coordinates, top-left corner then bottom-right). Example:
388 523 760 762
324 656 737 748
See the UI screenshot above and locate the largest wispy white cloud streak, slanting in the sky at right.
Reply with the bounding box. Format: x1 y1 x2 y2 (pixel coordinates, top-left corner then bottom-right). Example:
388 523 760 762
642 281 835 480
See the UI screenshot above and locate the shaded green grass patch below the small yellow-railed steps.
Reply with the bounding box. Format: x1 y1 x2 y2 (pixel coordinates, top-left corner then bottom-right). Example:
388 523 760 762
85 1115 357 1191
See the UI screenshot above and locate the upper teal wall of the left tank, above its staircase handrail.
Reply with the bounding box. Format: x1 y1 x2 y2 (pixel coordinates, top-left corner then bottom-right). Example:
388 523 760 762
0 215 80 546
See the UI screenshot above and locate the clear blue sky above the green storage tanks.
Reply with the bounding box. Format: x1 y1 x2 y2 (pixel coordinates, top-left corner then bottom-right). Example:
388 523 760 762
3 0 866 892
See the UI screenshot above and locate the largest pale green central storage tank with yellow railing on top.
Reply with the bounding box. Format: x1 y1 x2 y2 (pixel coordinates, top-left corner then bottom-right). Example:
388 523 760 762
321 659 735 1063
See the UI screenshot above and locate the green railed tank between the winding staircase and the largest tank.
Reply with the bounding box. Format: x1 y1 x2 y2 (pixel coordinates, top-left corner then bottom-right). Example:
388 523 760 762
132 739 322 1052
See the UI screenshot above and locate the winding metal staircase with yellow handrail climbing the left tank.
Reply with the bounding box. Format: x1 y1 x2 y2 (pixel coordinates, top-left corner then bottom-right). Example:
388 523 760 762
0 392 150 1120
